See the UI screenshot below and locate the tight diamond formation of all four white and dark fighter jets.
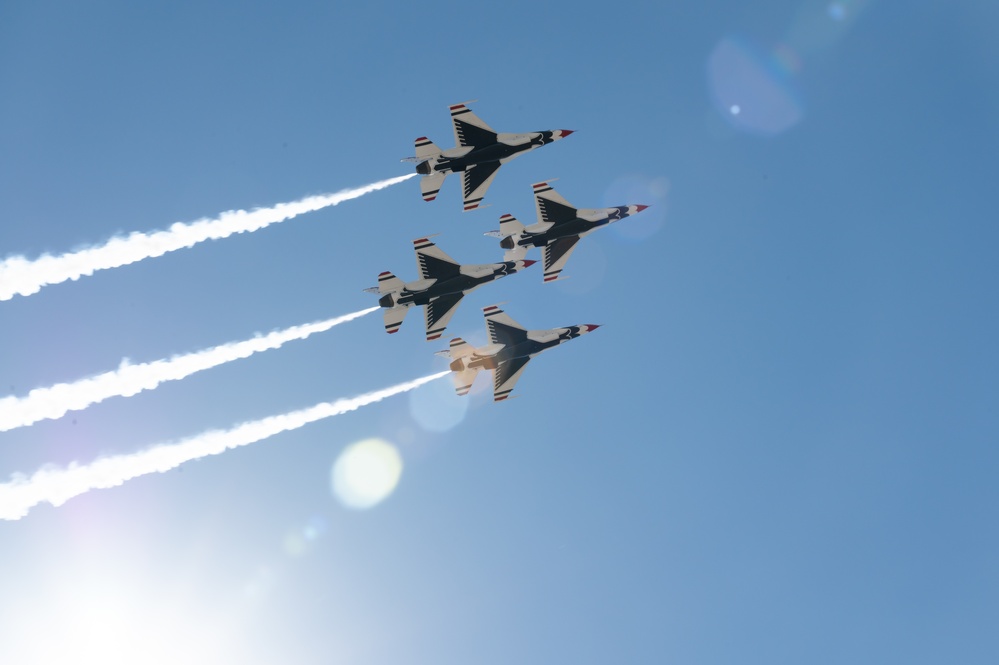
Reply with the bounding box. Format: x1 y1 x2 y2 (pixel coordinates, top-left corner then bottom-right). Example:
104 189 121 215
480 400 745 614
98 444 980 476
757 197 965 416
376 103 648 402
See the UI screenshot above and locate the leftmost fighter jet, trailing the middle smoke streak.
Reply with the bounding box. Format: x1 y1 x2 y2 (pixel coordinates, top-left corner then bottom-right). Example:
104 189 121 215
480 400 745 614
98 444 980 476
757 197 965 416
365 238 536 341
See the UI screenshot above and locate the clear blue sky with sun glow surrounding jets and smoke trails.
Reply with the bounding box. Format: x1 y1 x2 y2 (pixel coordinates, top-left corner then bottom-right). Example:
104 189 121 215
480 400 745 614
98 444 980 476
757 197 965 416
0 0 999 665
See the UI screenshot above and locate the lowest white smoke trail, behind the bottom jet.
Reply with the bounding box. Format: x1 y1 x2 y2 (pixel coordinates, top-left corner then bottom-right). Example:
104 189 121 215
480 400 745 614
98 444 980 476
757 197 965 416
0 370 449 520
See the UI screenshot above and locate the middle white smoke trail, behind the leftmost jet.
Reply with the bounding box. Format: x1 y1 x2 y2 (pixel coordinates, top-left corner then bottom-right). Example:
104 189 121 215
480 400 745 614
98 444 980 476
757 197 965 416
0 307 378 432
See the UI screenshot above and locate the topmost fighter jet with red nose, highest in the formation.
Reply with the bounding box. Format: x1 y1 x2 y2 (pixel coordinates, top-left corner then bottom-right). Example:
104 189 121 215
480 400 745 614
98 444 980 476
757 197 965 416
403 104 572 211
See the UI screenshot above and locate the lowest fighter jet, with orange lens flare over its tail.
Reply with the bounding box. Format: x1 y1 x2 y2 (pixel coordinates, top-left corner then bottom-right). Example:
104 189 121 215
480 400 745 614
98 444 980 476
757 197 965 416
438 305 600 402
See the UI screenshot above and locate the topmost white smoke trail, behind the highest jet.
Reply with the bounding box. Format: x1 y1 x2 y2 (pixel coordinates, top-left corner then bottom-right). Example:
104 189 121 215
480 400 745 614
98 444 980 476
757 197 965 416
0 173 416 300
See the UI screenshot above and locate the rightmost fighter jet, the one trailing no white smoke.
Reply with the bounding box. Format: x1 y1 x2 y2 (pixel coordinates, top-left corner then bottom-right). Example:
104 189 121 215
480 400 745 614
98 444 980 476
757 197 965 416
486 182 649 282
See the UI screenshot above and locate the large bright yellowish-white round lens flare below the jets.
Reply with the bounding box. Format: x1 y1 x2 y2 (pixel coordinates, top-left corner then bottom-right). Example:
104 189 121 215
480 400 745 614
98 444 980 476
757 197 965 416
332 439 402 510
